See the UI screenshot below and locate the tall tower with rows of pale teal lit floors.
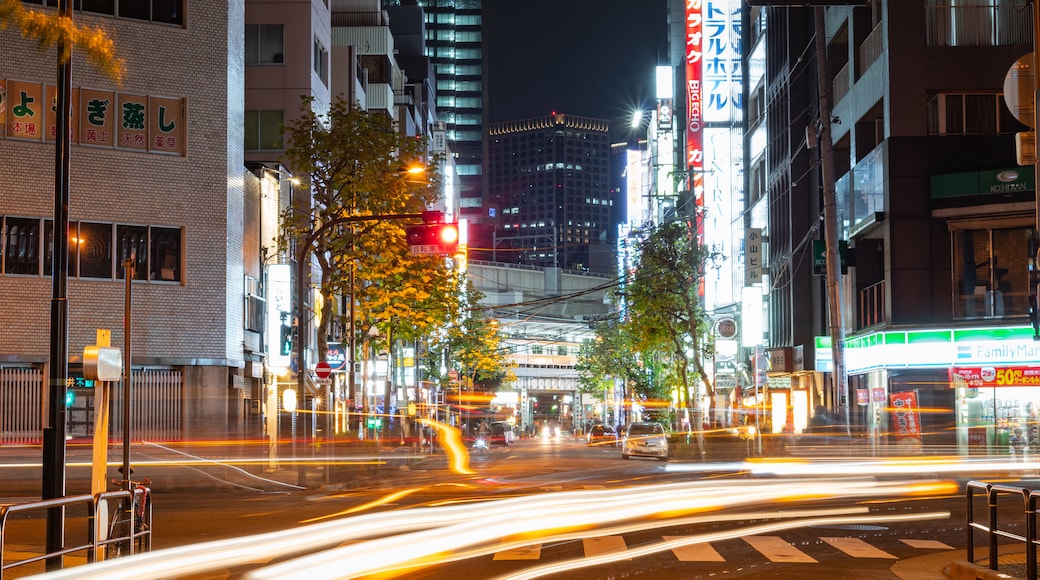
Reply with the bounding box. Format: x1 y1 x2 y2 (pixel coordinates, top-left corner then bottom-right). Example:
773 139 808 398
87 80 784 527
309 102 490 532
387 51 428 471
384 0 489 225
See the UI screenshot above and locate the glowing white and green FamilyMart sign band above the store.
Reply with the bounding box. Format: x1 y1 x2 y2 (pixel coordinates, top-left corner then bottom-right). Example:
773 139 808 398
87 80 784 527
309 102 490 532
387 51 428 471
815 326 1040 372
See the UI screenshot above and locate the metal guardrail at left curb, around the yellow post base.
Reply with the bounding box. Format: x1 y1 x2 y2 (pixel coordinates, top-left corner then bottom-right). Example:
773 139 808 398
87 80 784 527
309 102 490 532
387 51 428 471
0 489 152 579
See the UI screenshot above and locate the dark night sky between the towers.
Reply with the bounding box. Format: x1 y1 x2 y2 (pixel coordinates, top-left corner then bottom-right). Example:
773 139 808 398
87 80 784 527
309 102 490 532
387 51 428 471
483 0 668 138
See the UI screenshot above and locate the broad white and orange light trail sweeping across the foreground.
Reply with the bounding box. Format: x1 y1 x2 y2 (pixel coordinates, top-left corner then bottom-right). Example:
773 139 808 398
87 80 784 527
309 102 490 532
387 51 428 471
28 477 957 580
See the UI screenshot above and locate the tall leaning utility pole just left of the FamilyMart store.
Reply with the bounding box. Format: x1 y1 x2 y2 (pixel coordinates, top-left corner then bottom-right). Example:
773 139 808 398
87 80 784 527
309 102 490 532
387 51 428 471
813 5 852 437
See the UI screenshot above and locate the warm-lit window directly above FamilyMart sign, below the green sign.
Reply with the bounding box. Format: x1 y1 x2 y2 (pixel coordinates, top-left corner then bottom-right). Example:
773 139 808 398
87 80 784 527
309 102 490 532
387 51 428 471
952 228 1032 319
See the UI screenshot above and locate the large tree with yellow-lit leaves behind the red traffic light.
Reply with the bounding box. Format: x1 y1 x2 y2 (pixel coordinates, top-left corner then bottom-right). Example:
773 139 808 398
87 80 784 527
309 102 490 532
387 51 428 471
282 99 459 365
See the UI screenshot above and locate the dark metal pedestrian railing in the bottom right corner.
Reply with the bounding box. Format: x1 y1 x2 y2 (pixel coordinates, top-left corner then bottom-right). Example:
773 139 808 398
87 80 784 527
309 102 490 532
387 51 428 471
965 481 1040 579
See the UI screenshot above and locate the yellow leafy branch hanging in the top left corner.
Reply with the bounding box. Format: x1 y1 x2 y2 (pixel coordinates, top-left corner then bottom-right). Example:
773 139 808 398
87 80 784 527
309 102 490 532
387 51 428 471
0 0 126 84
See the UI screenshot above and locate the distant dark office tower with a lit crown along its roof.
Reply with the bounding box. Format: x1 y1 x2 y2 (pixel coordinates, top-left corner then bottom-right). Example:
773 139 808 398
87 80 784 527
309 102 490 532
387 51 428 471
488 113 616 273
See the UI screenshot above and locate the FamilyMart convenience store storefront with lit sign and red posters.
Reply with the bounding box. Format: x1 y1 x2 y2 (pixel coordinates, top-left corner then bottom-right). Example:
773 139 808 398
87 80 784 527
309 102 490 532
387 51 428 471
815 326 1040 455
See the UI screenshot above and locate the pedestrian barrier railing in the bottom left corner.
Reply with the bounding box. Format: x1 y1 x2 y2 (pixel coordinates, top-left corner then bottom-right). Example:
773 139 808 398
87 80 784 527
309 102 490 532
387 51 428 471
0 490 152 580
